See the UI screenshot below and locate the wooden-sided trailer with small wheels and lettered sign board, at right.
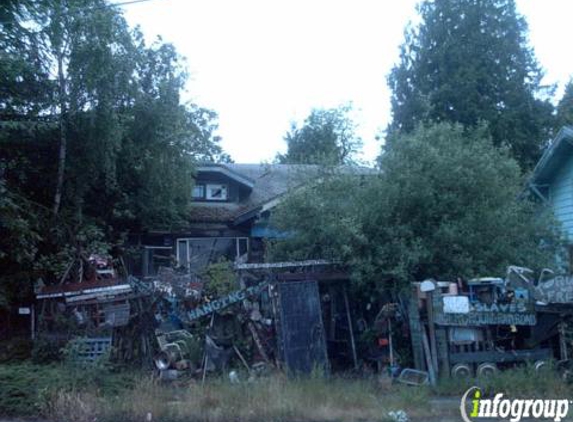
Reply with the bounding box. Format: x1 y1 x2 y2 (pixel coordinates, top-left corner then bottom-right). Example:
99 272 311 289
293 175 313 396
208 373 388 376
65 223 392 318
408 267 563 381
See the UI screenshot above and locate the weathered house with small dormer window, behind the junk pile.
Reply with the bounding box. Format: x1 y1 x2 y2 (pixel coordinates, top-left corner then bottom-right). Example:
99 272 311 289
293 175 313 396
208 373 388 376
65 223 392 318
130 163 332 276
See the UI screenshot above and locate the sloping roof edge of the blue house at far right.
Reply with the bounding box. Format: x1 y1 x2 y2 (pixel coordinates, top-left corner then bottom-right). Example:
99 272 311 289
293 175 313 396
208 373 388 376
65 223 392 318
530 126 573 185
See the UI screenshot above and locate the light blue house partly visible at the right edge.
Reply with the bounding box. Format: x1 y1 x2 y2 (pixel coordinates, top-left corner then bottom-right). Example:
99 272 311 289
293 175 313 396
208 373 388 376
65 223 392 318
528 126 573 269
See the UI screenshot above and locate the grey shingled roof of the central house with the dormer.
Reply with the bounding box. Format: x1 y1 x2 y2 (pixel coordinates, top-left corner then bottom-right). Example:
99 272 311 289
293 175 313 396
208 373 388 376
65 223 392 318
191 163 376 224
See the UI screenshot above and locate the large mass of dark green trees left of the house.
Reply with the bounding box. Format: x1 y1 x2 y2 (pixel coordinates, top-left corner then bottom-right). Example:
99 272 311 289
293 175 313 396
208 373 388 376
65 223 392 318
0 0 229 300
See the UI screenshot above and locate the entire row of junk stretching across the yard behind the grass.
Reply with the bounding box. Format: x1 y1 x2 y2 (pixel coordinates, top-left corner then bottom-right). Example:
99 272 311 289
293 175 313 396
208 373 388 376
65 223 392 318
32 251 573 384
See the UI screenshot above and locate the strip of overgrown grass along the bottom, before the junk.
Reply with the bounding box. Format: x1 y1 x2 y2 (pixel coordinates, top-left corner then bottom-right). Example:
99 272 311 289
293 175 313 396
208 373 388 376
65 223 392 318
4 363 573 422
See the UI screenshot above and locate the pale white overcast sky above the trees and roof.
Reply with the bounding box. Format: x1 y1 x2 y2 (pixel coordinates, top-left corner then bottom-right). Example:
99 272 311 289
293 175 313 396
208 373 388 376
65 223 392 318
117 0 573 164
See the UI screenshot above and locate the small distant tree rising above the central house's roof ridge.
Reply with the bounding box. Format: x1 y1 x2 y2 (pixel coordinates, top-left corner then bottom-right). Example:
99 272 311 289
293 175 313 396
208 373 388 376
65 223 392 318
277 105 362 165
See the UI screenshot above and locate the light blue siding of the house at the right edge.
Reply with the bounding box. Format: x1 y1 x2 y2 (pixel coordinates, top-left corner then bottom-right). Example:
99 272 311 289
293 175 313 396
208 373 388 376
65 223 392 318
549 156 573 242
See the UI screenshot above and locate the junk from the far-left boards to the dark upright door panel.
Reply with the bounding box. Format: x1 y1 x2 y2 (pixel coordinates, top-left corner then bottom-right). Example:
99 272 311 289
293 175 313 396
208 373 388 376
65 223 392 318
36 255 406 380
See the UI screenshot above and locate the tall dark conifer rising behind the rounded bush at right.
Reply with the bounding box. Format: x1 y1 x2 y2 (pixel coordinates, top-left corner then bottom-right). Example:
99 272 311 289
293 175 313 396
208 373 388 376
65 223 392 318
388 0 553 169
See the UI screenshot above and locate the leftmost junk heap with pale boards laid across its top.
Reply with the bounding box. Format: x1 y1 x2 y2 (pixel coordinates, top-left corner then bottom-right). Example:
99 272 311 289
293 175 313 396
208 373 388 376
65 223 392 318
35 255 154 363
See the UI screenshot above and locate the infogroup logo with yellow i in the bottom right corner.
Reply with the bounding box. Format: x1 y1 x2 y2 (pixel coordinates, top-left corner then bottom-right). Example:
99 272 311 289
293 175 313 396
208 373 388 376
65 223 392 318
460 387 570 422
